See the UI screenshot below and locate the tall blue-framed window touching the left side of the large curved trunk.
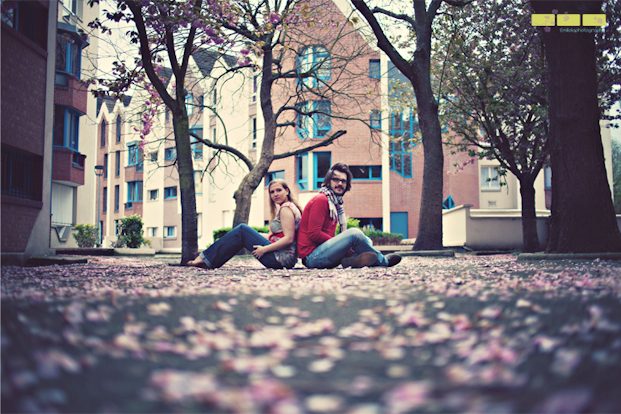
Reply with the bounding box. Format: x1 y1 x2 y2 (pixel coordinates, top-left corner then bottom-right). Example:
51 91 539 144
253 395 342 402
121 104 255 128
389 112 419 178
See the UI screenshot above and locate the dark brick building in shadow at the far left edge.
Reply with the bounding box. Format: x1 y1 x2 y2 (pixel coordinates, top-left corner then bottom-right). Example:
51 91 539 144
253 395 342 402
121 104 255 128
2 1 57 264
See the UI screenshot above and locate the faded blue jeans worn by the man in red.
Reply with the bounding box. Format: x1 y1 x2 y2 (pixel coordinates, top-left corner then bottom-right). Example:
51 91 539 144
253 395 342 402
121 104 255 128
303 228 388 269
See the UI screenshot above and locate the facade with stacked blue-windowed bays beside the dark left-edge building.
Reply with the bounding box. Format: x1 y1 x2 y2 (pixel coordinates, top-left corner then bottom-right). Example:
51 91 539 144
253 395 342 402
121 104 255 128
49 0 99 249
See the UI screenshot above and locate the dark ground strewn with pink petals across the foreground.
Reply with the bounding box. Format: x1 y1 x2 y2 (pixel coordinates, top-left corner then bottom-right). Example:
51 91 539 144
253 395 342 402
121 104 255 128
1 255 621 413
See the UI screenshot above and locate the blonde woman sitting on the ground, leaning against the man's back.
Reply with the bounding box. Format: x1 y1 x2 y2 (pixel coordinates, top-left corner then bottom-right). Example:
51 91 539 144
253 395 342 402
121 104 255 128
188 179 302 269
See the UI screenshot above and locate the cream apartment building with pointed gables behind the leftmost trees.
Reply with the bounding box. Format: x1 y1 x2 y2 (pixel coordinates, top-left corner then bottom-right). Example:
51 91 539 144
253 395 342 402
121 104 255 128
97 49 263 252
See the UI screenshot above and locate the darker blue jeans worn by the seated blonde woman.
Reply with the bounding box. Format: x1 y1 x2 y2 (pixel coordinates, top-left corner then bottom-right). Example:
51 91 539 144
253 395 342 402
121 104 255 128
200 224 283 269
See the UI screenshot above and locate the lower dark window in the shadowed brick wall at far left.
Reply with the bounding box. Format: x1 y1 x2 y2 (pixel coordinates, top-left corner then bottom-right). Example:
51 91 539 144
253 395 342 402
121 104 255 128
2 145 43 201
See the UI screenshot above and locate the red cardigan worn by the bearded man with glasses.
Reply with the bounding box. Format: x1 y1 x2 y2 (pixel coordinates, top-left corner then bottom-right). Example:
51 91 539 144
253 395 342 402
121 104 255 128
298 194 338 259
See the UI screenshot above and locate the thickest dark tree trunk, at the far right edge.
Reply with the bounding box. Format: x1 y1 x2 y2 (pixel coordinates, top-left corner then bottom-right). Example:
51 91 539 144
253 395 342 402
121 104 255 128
531 1 621 253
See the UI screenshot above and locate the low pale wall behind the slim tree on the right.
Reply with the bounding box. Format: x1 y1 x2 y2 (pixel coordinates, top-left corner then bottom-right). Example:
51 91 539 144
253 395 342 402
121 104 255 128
442 204 550 250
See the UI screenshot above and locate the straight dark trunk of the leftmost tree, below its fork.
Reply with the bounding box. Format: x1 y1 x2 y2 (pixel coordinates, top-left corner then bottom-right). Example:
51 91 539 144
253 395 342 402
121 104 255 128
173 116 198 265
